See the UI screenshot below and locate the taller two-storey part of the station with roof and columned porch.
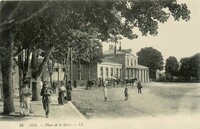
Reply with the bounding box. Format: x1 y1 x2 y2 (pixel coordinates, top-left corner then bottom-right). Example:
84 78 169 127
104 47 149 82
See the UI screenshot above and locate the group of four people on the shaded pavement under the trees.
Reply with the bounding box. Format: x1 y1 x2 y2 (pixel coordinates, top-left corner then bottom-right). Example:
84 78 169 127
20 81 72 118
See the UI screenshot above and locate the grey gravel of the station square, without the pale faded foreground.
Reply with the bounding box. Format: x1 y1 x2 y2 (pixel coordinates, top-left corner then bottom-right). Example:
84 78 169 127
72 82 200 119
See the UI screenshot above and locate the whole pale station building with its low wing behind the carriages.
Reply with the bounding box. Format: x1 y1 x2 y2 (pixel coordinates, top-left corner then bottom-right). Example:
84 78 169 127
73 46 149 82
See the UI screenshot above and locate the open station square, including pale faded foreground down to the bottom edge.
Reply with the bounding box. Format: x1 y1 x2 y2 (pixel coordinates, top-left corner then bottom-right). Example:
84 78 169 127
73 83 200 129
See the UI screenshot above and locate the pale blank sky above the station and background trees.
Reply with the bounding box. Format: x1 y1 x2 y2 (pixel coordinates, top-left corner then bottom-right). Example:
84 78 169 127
103 0 200 61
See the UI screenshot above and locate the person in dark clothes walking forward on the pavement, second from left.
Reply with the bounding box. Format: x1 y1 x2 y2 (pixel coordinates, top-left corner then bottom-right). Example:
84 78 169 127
40 81 52 118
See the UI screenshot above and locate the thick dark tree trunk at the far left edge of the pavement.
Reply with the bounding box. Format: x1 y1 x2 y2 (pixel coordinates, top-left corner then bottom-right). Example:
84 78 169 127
1 31 15 115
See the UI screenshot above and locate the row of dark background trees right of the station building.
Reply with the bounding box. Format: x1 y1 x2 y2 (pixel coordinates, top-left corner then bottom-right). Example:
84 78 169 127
137 47 200 82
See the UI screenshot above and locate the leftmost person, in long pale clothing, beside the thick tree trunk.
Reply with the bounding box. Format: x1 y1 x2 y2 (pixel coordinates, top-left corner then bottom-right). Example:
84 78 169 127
20 81 32 116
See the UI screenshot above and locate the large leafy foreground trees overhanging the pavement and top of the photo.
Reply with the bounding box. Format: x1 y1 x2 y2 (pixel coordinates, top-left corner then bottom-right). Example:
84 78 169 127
0 0 190 114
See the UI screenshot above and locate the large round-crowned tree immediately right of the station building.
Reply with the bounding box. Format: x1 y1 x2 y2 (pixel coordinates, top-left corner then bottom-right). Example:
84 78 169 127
137 47 164 79
